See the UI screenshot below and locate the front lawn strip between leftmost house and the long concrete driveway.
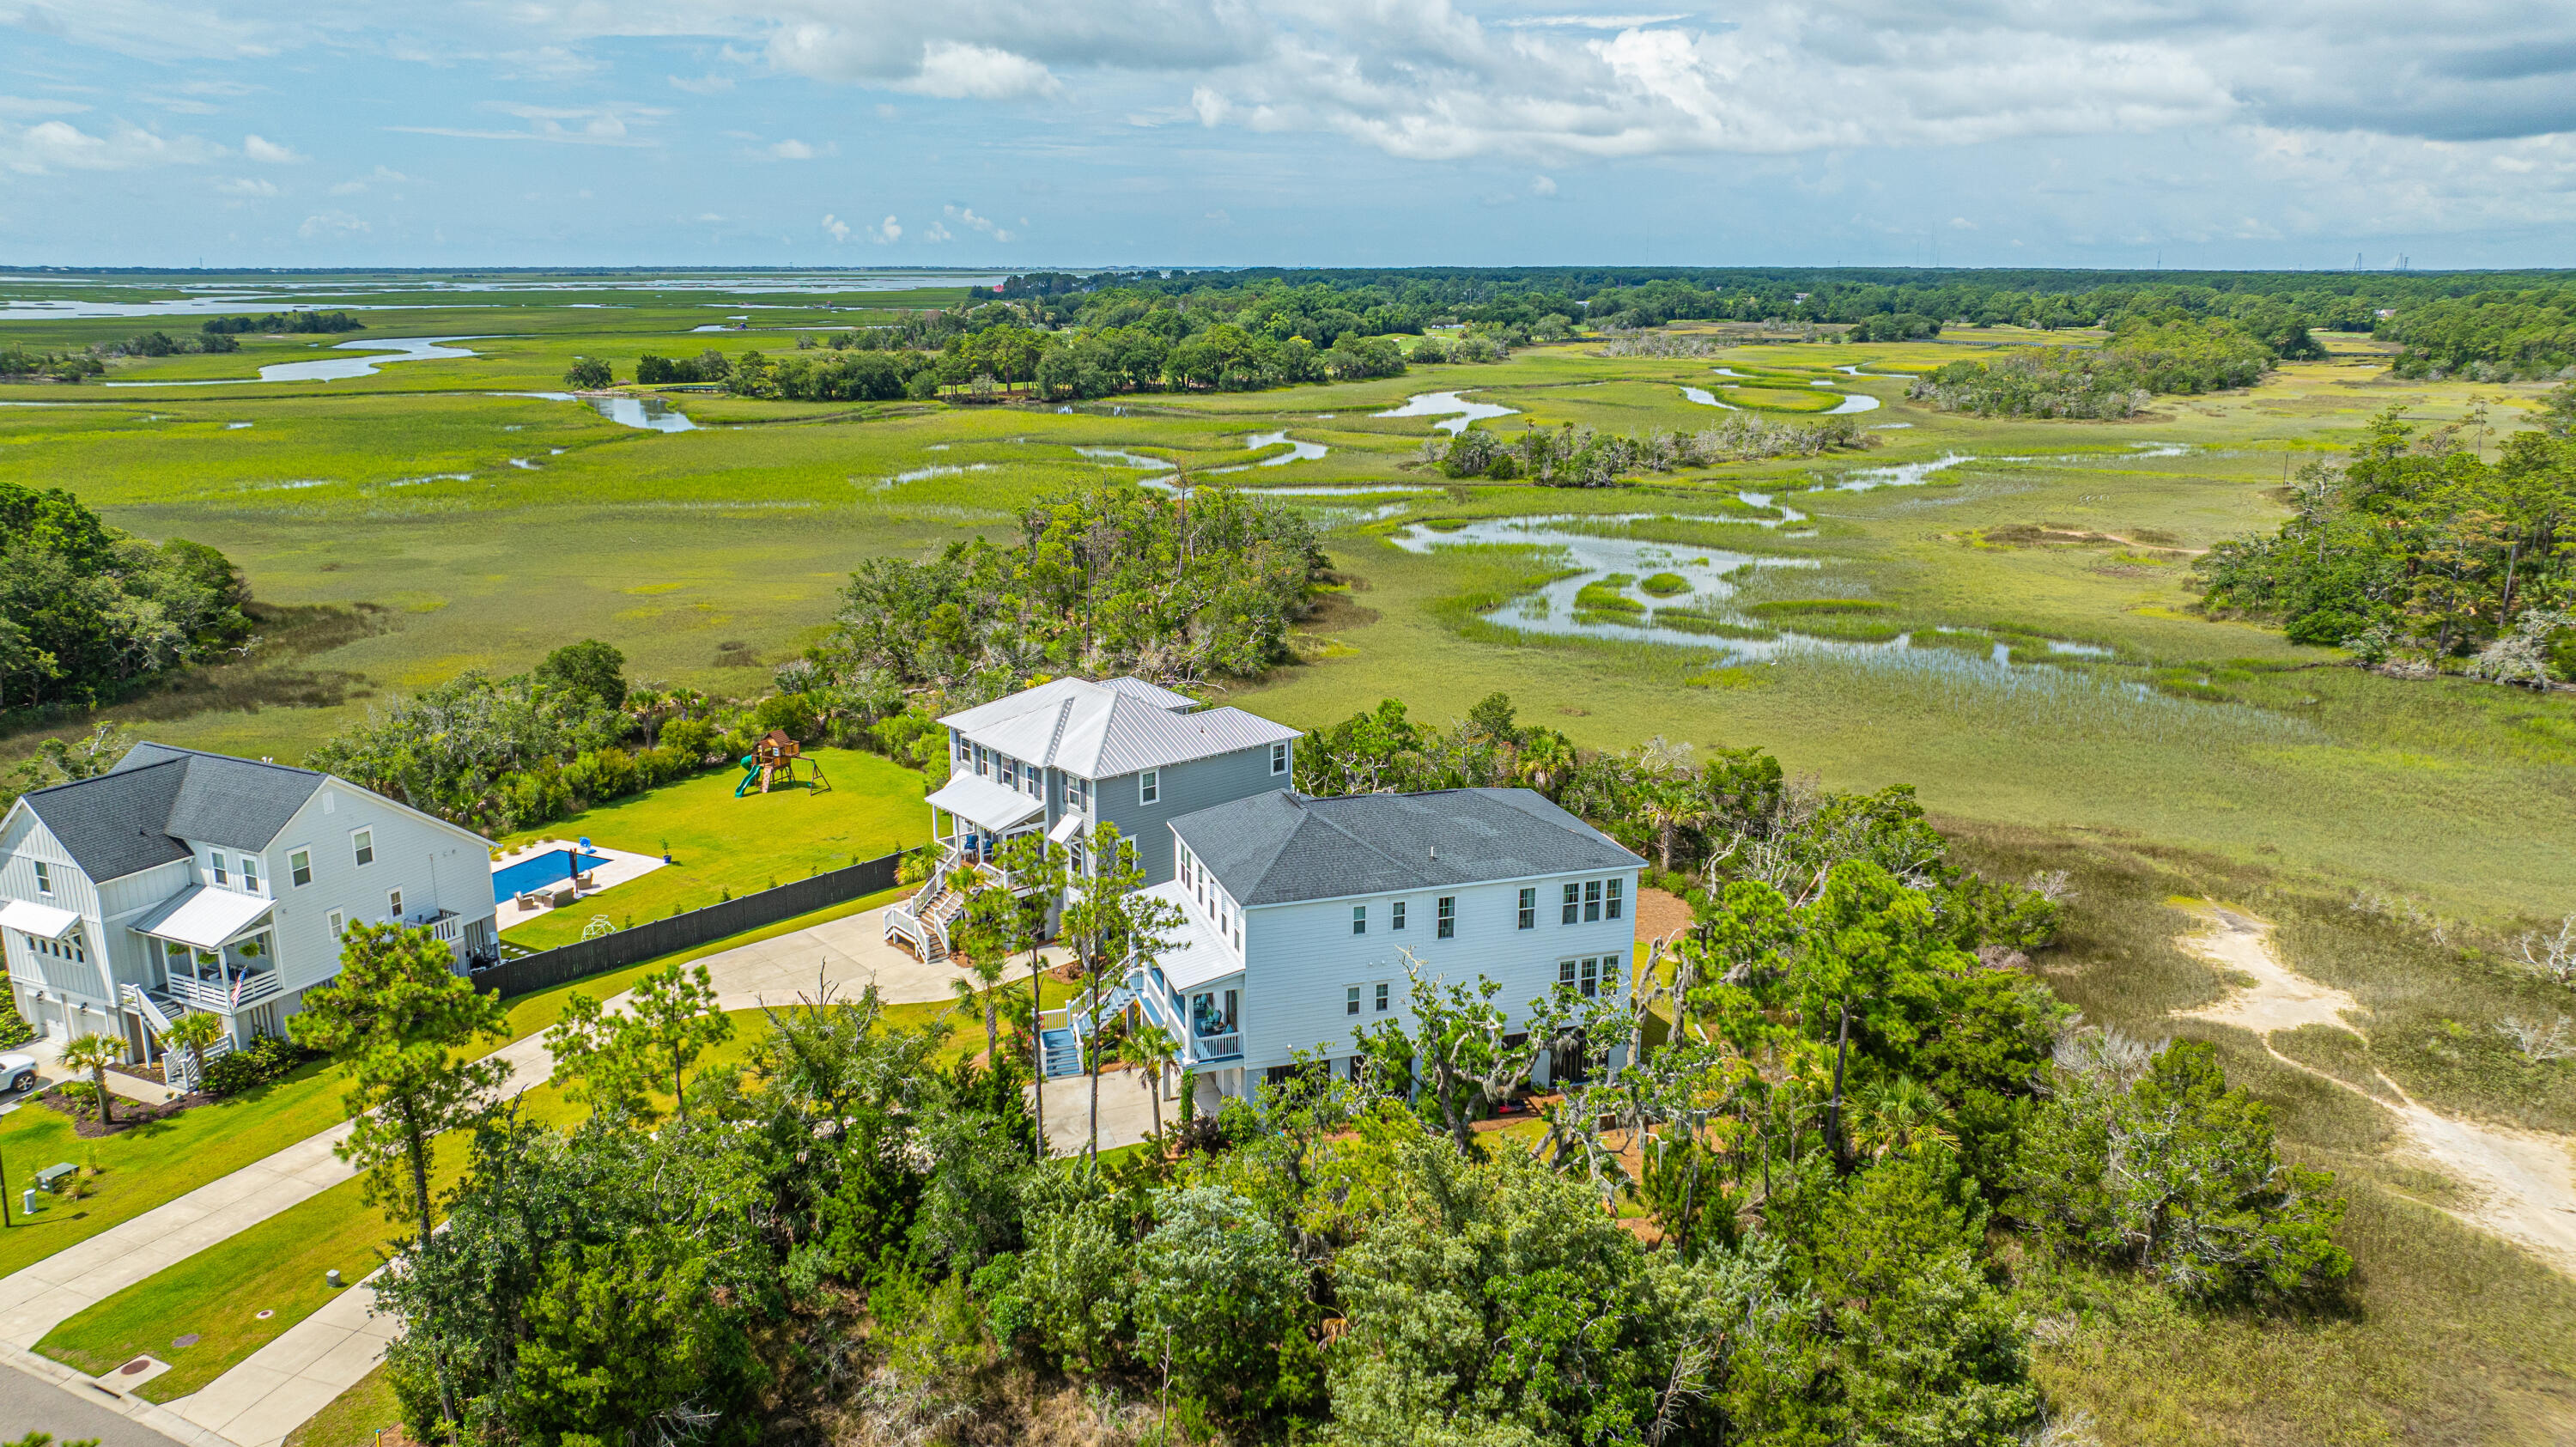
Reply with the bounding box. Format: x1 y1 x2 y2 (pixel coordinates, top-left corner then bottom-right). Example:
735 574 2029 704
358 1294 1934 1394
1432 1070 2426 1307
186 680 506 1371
0 1063 345 1274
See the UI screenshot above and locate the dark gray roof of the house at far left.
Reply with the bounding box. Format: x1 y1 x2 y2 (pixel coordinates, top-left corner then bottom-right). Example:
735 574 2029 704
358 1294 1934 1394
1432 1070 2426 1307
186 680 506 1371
26 744 325 880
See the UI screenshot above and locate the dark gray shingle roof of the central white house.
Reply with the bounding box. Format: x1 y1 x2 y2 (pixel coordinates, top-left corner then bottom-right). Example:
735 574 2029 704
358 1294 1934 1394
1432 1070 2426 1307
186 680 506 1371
1172 787 1643 906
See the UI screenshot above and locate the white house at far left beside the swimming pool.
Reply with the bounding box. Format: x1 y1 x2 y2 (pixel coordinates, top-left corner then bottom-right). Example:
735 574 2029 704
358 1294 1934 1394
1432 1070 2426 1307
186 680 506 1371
0 744 497 1061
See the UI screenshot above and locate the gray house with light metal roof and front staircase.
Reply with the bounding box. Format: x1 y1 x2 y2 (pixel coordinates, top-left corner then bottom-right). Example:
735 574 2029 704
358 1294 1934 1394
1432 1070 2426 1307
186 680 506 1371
886 678 1298 960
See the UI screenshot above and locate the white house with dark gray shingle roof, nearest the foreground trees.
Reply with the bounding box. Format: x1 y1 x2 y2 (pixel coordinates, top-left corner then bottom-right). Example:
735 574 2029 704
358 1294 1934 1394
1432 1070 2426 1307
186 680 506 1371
1077 787 1643 1097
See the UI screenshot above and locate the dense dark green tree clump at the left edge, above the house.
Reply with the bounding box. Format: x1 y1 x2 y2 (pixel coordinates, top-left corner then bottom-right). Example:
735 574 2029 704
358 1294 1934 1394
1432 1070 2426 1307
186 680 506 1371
0 482 250 714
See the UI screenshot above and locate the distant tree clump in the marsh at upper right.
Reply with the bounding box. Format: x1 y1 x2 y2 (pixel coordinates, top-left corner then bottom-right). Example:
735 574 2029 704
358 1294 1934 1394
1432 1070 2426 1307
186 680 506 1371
1906 317 2287 417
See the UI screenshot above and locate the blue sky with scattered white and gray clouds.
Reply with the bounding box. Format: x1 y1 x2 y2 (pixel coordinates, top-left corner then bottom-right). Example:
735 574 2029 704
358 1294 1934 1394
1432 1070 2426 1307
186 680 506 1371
0 0 2576 271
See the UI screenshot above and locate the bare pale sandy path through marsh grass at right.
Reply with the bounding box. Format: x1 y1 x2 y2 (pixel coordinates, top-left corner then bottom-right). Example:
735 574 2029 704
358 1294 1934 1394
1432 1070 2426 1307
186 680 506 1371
2184 906 2576 1274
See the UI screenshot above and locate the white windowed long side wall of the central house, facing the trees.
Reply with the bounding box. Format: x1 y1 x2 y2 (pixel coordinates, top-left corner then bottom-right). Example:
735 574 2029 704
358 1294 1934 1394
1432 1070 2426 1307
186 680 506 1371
1239 867 1636 1071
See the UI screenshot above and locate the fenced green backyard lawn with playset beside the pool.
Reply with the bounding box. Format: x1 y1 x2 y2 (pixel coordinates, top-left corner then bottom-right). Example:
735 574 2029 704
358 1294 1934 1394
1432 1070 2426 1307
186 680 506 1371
502 749 930 950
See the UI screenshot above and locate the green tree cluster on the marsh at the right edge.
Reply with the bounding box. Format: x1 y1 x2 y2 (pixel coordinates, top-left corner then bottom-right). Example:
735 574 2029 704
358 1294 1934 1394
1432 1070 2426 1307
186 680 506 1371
2195 384 2576 685
